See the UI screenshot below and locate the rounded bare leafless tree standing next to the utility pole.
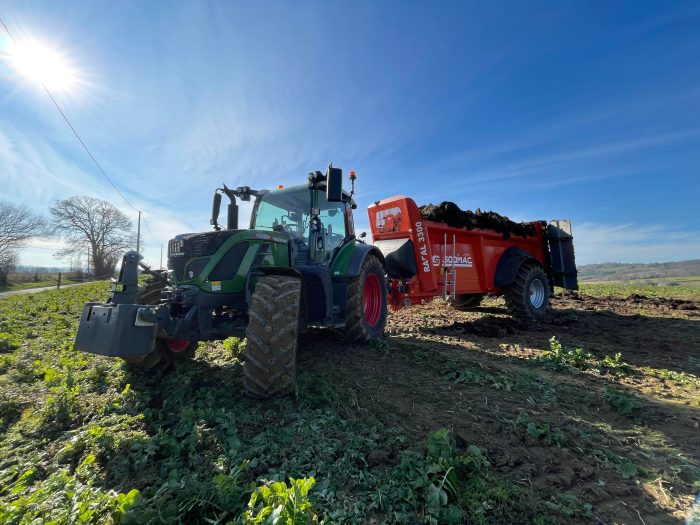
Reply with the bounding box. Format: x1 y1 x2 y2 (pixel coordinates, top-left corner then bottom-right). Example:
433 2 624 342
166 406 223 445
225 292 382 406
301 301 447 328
51 196 136 277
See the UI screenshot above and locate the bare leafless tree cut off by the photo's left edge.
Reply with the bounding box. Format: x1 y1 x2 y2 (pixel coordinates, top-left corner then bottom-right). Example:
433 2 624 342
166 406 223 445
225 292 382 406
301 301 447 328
0 201 46 284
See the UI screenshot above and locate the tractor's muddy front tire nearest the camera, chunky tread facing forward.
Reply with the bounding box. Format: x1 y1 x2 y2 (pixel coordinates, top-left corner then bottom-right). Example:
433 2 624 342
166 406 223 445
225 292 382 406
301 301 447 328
243 275 301 399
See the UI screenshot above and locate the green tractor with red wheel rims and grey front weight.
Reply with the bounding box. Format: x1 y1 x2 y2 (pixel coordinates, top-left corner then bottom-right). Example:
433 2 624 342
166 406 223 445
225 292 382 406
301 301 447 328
75 165 387 398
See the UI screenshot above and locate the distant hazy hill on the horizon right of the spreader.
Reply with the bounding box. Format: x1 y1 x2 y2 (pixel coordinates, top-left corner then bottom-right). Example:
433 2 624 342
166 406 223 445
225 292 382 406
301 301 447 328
578 259 700 282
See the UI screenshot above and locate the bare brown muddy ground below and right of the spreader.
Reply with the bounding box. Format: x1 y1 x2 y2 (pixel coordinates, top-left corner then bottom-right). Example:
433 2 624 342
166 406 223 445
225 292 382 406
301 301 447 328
300 292 700 525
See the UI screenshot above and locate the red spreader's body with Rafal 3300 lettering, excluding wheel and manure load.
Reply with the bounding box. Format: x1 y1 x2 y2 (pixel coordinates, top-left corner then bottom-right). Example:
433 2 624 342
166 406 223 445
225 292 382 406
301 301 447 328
368 196 578 308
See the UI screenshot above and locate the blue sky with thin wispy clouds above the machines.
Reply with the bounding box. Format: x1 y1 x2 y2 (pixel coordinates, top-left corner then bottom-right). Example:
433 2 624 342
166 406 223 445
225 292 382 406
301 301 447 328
0 0 700 265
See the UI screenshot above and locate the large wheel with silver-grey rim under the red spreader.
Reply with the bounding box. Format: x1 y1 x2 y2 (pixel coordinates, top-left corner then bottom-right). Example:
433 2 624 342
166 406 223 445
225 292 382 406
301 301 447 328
505 263 550 319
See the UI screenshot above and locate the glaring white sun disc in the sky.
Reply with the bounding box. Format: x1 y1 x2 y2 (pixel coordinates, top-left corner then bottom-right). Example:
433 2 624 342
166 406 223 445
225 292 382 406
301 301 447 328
8 40 77 91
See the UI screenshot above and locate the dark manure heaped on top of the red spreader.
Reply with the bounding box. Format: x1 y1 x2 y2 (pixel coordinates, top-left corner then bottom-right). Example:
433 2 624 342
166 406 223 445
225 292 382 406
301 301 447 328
419 201 535 239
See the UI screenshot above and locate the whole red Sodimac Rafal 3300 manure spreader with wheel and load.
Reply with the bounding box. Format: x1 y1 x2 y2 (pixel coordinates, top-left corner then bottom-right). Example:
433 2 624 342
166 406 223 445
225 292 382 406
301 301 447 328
367 196 578 319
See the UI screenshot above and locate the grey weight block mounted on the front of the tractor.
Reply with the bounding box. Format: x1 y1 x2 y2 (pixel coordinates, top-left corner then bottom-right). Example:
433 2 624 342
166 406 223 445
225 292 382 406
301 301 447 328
73 252 158 357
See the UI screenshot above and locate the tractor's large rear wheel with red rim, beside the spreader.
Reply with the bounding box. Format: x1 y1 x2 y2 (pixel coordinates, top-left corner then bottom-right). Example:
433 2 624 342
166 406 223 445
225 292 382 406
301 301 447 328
345 255 387 343
